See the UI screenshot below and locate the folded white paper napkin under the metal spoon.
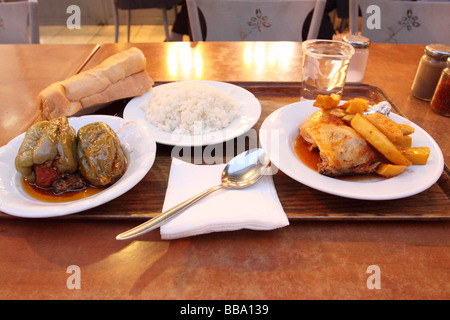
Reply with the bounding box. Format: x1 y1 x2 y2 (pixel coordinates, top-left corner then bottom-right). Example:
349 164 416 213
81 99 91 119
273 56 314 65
160 158 289 239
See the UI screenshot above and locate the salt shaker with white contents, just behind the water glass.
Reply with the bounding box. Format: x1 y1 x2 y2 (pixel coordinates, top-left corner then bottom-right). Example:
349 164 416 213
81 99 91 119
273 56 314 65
342 34 370 82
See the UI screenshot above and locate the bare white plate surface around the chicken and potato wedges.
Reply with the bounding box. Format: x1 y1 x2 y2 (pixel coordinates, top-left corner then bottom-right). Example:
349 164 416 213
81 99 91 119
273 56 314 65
259 101 444 200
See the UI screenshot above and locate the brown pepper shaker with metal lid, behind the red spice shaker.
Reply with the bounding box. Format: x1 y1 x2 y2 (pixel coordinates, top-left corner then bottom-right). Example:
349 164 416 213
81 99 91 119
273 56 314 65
411 44 450 101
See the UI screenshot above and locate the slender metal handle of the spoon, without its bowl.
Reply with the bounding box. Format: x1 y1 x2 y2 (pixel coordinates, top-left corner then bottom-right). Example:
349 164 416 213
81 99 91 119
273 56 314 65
116 185 223 240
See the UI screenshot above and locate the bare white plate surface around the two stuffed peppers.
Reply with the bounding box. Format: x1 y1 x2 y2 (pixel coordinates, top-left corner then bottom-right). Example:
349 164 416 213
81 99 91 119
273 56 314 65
0 115 156 218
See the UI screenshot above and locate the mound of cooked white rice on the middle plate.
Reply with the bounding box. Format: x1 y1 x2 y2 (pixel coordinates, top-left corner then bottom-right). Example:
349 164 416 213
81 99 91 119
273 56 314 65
141 81 241 134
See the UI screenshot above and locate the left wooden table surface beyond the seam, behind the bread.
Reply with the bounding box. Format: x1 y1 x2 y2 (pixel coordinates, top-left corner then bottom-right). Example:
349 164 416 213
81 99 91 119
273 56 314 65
0 44 99 146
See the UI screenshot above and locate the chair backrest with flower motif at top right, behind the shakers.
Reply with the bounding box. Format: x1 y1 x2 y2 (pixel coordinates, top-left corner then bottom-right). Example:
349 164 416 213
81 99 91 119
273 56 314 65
350 0 450 44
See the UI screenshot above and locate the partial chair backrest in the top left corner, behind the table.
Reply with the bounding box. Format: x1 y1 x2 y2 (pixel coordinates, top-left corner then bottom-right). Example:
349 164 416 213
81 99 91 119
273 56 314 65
0 0 39 43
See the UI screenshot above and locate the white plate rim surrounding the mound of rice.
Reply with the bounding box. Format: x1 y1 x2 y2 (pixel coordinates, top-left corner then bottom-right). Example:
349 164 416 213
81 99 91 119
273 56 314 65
123 80 261 147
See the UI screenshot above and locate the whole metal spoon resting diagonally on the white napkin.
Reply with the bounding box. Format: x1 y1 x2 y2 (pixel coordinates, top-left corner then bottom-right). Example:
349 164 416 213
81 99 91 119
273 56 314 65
116 149 270 240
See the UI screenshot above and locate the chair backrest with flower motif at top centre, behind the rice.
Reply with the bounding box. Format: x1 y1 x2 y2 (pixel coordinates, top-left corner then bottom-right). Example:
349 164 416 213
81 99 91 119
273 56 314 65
186 0 326 41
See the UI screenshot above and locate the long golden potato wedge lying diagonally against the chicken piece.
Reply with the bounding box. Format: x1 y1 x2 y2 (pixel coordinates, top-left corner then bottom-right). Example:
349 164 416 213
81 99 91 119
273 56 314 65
350 113 411 166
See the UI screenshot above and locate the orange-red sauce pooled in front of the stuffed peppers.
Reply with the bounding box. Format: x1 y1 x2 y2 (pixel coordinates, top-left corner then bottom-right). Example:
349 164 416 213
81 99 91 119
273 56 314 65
22 178 105 203
